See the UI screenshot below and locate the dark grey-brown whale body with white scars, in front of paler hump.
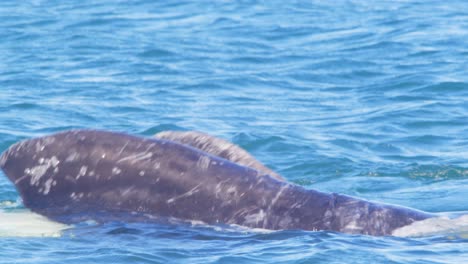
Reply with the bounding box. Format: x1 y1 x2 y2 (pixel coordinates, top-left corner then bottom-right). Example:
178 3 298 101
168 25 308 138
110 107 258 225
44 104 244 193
0 130 434 236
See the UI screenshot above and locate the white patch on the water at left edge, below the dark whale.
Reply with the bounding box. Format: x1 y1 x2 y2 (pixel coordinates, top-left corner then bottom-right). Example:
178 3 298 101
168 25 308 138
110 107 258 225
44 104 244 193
0 209 70 237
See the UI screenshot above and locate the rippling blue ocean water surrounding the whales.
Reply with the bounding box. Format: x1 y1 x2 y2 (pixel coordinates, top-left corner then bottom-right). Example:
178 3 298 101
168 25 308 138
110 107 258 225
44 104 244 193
0 0 468 264
